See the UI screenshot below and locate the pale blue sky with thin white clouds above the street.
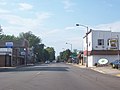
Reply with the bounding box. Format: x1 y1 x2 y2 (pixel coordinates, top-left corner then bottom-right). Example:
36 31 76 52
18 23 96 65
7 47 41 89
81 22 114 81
0 0 120 55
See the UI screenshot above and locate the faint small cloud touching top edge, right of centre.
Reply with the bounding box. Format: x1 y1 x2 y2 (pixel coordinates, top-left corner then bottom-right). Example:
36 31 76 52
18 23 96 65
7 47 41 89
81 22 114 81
63 0 75 12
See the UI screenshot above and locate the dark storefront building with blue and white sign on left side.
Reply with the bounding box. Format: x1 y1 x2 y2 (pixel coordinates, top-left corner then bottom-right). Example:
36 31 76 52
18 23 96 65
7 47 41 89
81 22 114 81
0 39 29 67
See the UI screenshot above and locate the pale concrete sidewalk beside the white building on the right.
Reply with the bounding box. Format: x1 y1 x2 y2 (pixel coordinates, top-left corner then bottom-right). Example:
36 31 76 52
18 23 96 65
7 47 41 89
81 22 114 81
72 64 120 77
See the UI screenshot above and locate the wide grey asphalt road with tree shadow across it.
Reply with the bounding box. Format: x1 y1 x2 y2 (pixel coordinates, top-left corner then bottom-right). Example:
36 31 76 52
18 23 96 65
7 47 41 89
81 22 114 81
0 63 120 90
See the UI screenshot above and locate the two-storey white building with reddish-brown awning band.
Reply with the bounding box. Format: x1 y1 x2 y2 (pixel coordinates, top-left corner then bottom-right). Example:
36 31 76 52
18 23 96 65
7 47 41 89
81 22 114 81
83 30 120 67
